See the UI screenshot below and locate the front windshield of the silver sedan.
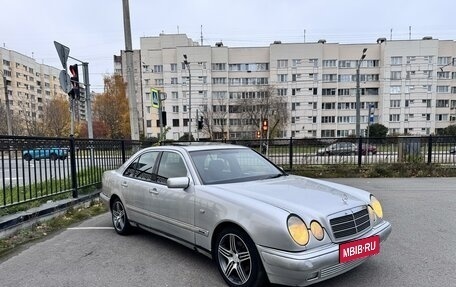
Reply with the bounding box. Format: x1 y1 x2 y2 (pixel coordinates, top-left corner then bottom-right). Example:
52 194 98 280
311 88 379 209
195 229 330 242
190 149 285 184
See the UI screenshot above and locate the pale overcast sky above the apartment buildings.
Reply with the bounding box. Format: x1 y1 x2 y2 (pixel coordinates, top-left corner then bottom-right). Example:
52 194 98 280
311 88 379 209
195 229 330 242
0 0 456 92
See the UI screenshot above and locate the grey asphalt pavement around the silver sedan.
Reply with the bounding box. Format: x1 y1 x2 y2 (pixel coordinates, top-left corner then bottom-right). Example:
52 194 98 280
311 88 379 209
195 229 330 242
0 178 456 287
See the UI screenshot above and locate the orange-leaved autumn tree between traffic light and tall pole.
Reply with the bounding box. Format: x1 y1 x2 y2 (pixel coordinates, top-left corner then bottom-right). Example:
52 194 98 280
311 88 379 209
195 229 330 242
93 75 130 139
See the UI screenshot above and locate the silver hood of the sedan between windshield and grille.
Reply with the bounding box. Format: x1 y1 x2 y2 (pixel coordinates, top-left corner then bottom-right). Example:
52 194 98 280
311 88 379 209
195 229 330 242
213 175 370 218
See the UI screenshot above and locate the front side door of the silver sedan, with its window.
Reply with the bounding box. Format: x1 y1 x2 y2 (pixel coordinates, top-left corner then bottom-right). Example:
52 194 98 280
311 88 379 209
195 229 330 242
147 151 195 244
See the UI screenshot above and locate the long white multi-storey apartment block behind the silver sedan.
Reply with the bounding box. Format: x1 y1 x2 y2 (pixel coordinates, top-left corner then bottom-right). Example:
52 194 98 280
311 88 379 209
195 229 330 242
133 34 456 139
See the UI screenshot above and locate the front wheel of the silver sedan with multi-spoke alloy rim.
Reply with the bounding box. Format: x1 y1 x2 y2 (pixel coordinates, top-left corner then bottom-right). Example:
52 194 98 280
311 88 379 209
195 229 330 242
213 227 267 287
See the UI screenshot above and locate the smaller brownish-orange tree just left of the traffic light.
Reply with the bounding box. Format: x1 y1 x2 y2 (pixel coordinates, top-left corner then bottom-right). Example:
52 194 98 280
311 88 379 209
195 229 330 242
40 98 71 137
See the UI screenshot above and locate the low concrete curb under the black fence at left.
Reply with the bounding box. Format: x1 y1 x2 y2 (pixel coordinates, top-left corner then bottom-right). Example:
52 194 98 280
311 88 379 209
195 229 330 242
0 190 100 238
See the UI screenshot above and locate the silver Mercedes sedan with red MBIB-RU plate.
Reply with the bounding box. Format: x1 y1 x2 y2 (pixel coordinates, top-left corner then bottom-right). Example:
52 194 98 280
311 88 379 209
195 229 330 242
100 144 391 286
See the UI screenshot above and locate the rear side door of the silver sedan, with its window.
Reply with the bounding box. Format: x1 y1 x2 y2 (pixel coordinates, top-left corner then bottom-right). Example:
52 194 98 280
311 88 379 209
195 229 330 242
121 151 160 225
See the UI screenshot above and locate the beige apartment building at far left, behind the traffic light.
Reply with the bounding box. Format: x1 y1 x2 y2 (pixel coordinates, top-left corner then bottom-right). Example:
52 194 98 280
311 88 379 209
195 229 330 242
0 48 75 135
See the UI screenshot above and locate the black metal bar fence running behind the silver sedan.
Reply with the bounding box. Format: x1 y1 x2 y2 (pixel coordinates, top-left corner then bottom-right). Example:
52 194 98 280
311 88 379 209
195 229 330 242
0 136 456 210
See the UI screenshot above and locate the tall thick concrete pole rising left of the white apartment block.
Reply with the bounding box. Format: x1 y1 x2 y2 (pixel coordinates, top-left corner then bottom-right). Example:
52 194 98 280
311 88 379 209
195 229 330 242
122 0 139 140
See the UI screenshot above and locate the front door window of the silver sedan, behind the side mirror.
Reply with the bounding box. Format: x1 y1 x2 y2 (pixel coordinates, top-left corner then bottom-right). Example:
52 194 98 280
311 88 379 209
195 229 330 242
157 151 187 184
